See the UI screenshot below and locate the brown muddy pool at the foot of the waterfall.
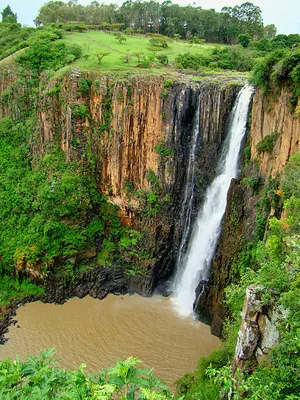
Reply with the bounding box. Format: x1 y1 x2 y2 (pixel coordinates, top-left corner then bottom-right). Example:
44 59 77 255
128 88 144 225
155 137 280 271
0 295 220 384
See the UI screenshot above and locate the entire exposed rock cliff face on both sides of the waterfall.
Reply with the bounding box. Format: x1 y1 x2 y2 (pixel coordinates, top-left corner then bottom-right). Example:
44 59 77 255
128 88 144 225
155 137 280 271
0 61 300 350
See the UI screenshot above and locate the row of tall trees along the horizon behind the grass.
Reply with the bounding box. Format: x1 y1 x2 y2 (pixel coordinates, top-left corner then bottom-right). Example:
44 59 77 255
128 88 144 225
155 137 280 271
34 0 277 44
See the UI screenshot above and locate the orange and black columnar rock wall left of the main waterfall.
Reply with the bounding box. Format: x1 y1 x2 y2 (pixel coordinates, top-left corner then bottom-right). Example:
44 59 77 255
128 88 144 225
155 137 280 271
0 66 241 294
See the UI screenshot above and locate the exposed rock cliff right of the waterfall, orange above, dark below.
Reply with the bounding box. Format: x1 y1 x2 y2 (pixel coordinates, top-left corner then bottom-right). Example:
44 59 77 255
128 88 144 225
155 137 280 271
196 90 300 337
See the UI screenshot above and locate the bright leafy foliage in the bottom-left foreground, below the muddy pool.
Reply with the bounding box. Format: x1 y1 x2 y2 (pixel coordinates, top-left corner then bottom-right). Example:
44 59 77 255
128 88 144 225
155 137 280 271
0 349 171 400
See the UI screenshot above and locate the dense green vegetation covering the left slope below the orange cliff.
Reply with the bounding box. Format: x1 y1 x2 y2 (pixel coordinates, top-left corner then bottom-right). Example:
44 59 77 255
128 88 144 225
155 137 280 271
0 118 149 284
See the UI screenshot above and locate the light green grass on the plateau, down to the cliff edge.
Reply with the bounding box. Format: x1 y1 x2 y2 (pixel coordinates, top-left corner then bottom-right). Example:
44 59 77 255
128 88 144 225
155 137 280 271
0 31 246 81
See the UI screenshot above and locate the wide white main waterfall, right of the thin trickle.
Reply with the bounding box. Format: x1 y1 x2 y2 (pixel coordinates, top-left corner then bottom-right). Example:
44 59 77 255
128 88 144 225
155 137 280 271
174 85 253 315
